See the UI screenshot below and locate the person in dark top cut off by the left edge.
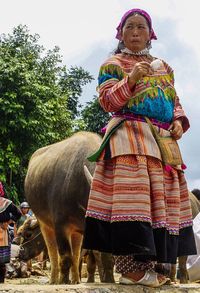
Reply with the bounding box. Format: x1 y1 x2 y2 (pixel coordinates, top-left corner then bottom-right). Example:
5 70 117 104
0 182 21 283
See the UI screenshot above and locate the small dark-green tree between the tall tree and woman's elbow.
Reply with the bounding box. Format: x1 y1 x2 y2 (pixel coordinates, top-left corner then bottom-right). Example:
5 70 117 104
80 96 111 134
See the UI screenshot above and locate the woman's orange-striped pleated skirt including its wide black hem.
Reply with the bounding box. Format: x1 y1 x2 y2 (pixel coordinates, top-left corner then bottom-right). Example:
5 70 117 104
83 155 196 263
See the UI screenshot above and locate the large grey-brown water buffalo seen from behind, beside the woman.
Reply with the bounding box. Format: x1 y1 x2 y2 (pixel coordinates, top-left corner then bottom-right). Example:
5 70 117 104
24 132 111 284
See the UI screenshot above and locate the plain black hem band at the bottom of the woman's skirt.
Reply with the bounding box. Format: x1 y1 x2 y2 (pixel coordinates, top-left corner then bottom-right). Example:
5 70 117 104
83 217 197 263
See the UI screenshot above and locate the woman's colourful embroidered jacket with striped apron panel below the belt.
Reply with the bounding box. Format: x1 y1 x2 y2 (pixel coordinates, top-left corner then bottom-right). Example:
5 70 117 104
93 54 190 159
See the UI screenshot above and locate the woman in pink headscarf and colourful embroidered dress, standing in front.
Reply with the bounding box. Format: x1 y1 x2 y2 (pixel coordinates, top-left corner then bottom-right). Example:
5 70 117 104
83 8 196 287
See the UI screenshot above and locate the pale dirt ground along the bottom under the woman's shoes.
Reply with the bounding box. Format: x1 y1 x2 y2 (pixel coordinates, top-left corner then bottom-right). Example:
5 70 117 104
0 262 200 293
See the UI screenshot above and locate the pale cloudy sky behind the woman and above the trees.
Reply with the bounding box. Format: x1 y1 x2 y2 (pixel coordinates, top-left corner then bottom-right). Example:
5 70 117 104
0 0 200 190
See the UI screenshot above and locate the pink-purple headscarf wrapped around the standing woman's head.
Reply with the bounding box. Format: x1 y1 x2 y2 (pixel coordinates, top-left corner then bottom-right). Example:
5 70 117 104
116 8 157 41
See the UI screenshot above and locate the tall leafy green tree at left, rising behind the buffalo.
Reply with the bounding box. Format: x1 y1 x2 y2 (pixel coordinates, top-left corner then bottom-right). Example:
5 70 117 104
0 25 92 202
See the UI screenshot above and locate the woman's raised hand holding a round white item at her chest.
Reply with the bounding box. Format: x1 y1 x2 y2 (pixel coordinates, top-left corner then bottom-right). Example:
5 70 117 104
128 61 153 88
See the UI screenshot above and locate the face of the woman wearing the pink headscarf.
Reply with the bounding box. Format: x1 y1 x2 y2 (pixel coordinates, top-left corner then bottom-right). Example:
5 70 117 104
122 15 150 52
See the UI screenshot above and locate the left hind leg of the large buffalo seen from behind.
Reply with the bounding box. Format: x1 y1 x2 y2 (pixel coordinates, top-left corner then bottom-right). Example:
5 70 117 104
40 223 59 284
